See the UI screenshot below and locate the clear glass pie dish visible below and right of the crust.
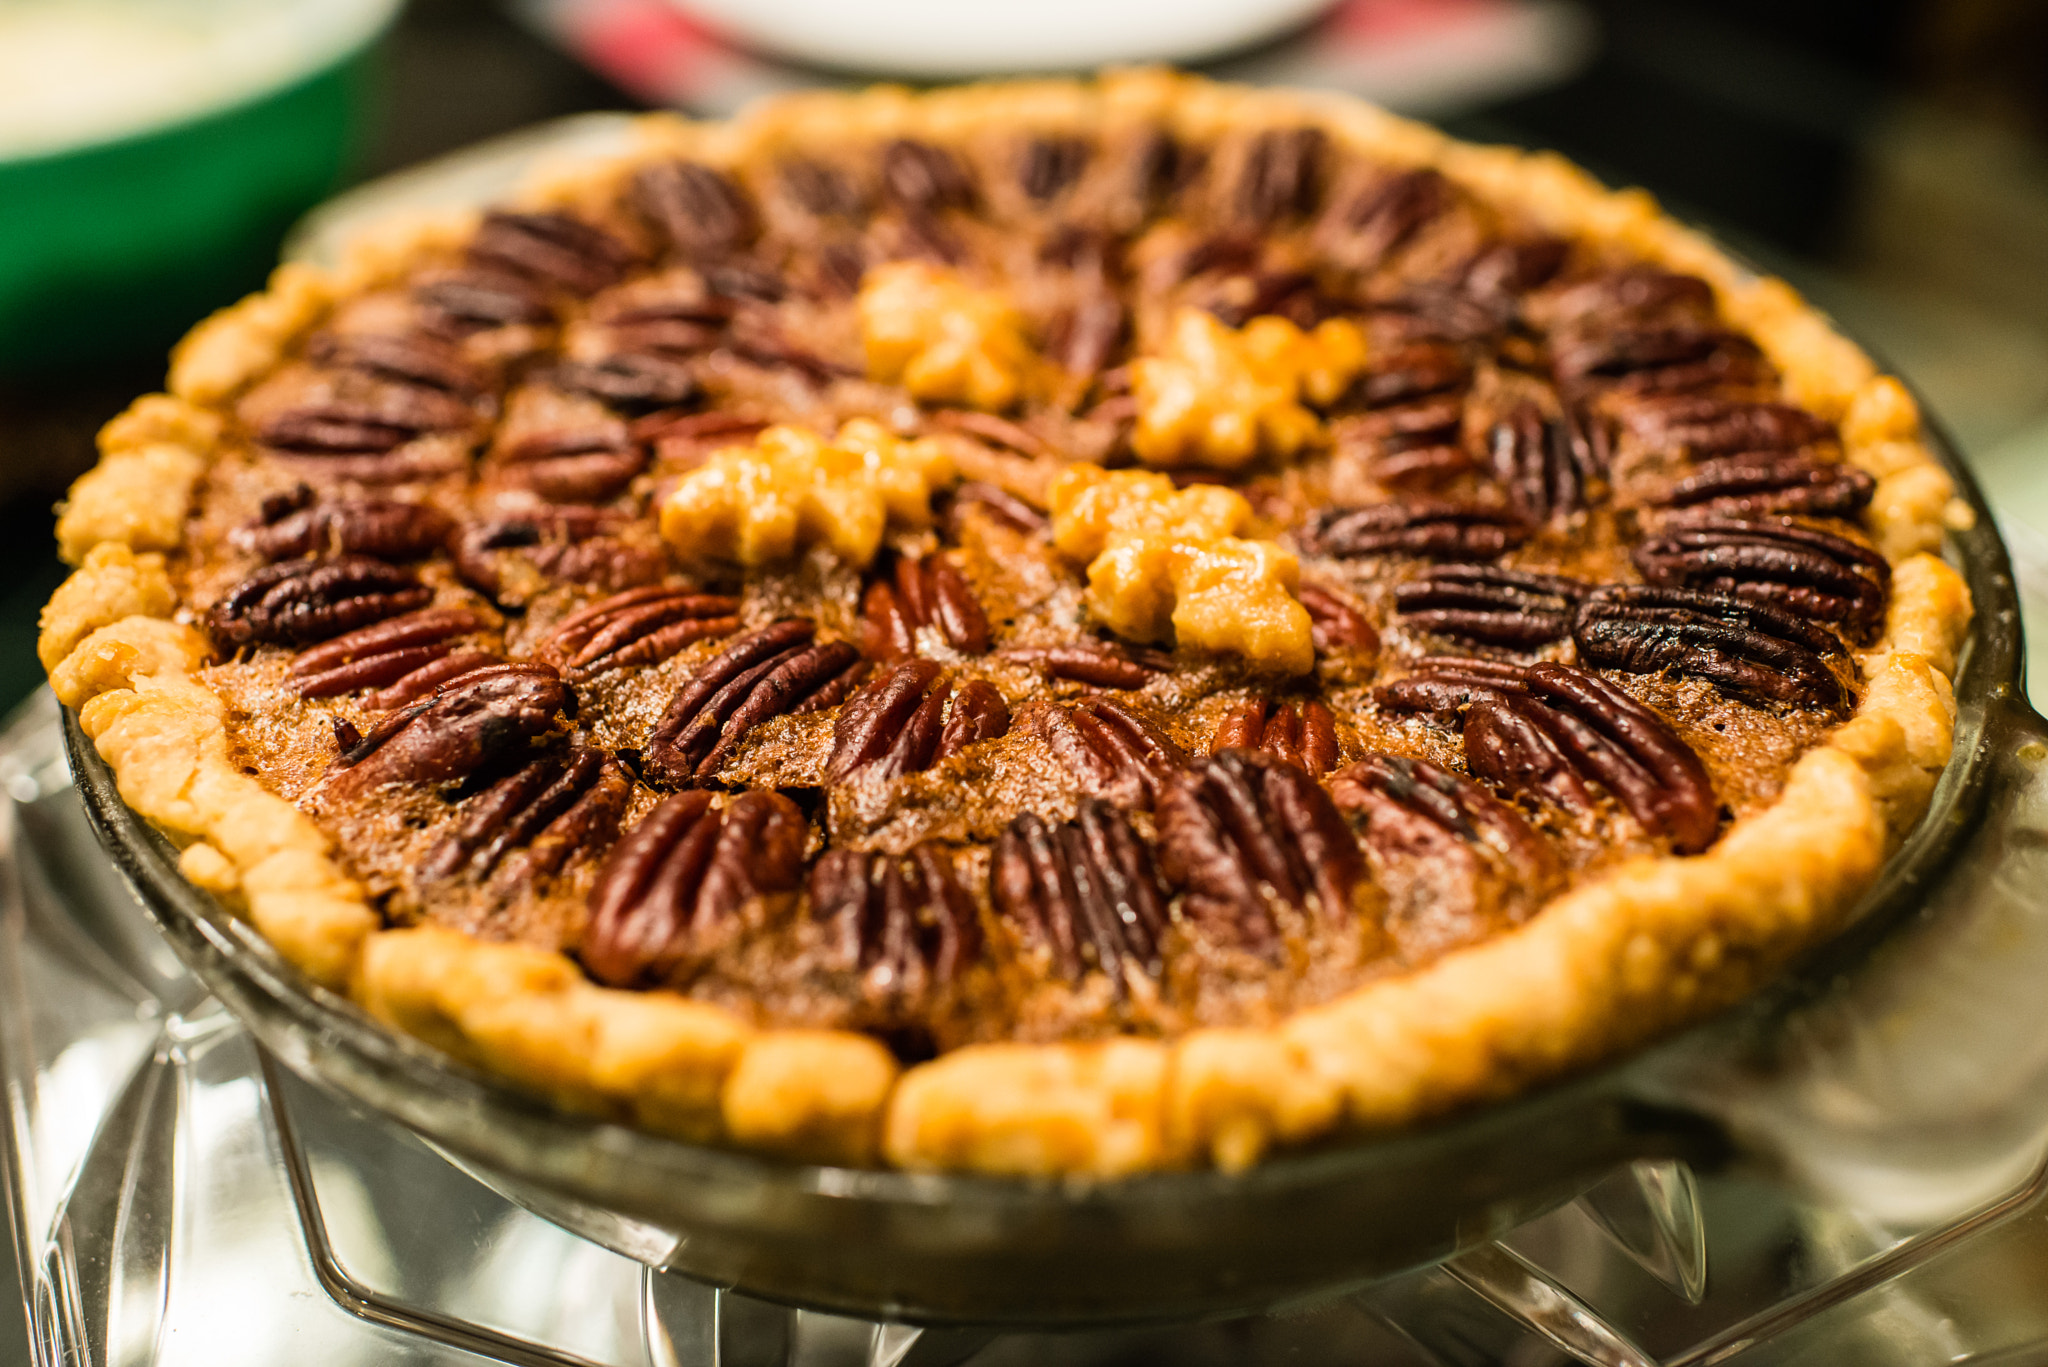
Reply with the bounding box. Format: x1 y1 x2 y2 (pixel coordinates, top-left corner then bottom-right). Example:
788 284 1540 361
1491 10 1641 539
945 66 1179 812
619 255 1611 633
51 383 2048 1324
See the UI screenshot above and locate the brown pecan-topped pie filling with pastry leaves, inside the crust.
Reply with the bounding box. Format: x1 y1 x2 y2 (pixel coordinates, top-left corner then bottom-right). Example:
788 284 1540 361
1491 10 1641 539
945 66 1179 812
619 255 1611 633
176 125 1888 1058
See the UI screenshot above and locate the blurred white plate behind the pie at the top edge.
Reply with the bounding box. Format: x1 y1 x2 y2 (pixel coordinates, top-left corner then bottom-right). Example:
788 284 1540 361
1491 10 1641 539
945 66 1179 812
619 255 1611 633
655 0 1329 78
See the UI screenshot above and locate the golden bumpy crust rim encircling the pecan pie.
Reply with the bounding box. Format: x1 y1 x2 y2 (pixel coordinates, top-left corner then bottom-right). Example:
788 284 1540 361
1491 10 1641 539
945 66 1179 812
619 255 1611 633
39 72 1970 1176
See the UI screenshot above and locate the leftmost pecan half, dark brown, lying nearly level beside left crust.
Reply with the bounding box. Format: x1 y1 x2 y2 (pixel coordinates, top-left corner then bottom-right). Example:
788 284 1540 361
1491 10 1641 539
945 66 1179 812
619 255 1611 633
207 555 434 650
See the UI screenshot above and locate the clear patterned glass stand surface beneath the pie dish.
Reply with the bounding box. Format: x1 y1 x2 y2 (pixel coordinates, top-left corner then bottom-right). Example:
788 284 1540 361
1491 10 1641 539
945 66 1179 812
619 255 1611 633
12 695 2048 1367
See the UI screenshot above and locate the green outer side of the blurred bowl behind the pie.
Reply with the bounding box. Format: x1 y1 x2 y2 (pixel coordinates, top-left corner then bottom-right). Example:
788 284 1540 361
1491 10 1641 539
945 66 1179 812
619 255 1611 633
0 6 401 373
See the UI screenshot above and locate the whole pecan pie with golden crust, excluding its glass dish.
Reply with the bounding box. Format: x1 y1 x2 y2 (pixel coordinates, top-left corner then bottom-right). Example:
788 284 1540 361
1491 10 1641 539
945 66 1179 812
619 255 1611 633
41 72 1970 1174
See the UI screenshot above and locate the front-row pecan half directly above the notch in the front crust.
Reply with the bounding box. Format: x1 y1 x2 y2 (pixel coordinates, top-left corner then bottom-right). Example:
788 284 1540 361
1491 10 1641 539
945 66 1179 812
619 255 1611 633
809 842 983 1014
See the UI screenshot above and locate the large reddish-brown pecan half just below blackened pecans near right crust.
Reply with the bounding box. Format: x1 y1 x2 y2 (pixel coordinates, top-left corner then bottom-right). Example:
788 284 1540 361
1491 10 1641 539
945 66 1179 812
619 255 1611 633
1464 664 1720 855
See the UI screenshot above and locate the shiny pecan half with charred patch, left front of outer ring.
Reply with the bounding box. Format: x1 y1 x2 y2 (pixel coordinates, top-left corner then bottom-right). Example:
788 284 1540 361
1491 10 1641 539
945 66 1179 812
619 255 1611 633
326 664 575 795
